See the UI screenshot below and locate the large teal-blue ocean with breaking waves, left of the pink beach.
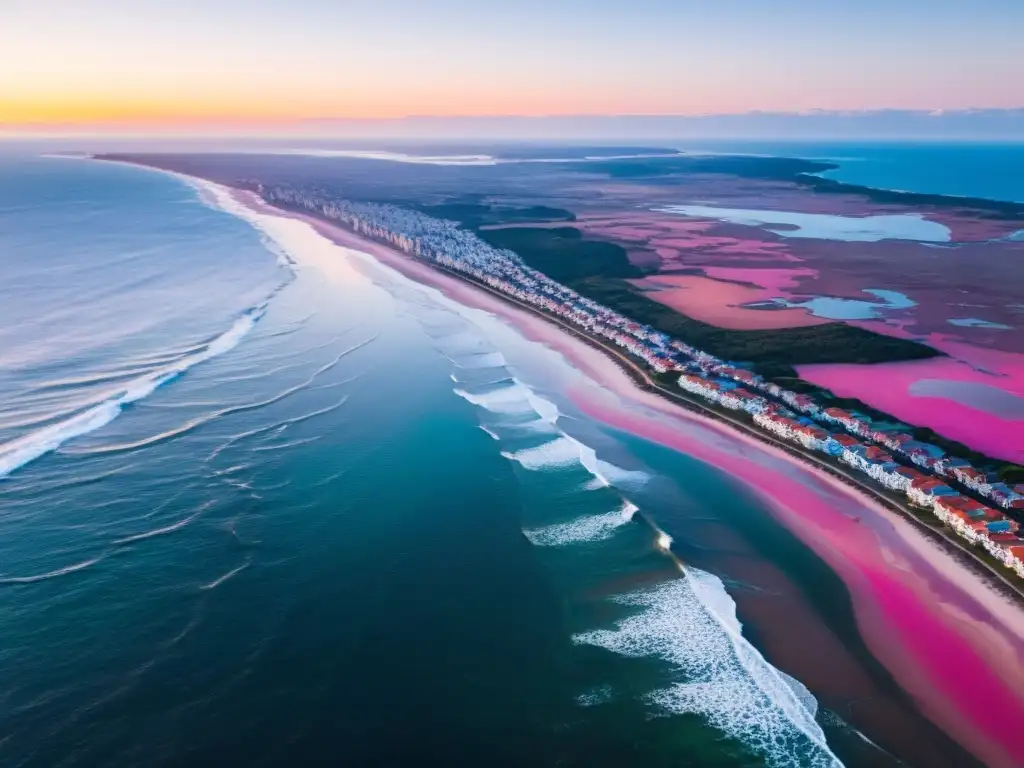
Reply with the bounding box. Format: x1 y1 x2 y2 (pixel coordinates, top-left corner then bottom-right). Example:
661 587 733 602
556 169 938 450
0 157 991 767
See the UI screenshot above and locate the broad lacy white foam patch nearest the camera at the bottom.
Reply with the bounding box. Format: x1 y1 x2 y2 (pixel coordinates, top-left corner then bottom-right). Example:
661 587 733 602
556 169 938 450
573 568 842 768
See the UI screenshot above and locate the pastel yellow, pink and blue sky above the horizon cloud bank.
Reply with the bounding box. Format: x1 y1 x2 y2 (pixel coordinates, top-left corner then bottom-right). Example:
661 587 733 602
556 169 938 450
0 0 1024 128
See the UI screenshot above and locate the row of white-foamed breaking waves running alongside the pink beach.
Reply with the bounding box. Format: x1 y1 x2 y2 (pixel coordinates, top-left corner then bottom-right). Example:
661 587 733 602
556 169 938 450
356 247 840 767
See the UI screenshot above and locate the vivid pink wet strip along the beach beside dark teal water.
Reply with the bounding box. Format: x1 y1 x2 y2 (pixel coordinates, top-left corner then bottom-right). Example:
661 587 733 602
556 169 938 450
572 388 1024 767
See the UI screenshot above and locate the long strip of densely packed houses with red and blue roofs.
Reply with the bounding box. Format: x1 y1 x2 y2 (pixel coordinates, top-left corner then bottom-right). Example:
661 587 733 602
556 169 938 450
262 183 1024 578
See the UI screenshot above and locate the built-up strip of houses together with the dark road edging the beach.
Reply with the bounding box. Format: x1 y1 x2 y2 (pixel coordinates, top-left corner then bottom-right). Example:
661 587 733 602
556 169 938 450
220 169 1024 595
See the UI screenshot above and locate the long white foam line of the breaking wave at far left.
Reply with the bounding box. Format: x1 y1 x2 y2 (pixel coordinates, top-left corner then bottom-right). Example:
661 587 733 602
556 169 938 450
0 304 266 478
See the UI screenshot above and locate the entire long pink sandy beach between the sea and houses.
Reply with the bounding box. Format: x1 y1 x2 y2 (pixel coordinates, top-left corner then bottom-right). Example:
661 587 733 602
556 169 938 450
199 182 1024 768
